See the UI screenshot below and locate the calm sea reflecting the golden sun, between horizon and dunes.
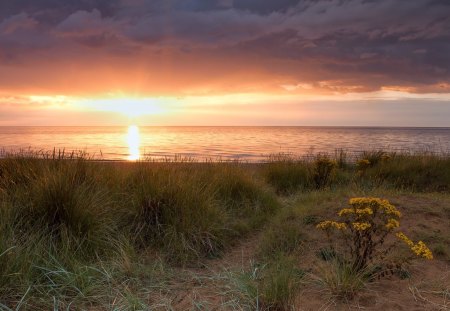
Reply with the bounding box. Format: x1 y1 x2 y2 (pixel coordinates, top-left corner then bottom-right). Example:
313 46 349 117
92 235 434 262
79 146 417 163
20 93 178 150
0 126 450 162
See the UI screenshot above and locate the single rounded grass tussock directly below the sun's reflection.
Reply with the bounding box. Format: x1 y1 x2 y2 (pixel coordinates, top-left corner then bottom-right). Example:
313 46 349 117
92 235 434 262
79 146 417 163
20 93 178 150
122 165 226 263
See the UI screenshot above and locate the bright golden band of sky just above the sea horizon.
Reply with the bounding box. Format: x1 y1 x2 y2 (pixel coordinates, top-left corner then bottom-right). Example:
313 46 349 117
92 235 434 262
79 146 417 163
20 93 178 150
0 87 450 127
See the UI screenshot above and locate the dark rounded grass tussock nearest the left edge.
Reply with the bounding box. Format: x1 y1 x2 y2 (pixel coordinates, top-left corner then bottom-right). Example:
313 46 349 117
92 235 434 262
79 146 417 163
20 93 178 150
9 160 117 256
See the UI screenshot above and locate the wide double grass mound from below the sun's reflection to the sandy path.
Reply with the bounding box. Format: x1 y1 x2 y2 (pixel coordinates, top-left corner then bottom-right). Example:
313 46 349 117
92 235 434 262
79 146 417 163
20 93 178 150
121 163 278 263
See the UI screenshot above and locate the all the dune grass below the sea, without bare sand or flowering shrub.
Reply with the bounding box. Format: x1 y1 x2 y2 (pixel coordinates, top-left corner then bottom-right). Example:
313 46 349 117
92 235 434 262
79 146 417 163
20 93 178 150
0 151 450 310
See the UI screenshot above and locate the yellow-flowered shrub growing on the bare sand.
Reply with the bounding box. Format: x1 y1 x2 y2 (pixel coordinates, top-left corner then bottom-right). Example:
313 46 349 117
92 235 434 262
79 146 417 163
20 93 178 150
317 197 433 271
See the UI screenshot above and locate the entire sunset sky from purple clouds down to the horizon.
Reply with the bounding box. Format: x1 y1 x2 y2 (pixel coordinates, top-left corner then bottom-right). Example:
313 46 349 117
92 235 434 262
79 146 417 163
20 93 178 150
0 0 450 126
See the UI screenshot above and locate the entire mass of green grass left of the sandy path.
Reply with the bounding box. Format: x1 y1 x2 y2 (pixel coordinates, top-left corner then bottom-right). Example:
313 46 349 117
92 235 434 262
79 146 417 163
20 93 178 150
0 154 280 309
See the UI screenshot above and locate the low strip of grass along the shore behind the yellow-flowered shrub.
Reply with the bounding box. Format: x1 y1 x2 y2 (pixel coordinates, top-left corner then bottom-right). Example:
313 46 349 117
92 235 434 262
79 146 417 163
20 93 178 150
261 150 450 195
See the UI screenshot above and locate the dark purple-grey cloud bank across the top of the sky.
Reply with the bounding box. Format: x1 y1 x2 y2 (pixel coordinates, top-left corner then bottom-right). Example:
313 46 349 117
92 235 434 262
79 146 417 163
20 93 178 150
0 0 450 92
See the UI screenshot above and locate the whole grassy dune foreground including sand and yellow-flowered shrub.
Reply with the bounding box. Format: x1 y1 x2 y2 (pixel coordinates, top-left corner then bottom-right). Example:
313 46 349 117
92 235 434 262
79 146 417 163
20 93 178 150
0 152 450 310
